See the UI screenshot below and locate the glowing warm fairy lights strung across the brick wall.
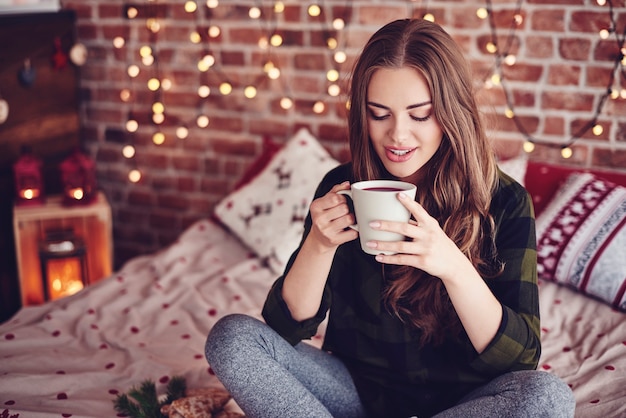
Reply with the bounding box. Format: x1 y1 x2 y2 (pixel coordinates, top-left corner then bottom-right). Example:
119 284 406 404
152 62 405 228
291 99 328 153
113 0 626 183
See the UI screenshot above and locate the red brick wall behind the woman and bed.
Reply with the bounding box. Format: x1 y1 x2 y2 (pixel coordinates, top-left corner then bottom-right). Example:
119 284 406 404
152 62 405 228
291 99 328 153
63 0 626 266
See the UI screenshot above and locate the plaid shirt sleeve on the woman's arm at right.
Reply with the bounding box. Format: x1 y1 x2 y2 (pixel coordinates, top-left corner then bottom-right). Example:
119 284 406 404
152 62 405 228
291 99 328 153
472 174 541 374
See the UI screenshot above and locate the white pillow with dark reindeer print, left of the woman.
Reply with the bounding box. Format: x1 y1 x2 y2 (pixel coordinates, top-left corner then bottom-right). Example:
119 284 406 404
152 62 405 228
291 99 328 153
215 128 339 274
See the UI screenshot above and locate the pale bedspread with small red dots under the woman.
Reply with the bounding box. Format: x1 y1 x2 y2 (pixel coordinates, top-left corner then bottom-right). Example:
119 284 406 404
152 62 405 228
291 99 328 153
0 220 626 418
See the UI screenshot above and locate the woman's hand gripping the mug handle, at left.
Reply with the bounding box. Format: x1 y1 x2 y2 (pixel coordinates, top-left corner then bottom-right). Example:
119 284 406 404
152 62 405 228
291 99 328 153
307 181 358 252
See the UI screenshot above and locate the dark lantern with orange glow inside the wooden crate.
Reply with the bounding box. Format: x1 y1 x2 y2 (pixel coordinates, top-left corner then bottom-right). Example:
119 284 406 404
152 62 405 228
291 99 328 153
39 231 89 301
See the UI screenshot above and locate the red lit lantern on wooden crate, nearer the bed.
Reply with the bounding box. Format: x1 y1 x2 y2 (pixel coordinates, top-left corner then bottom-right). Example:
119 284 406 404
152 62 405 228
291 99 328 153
60 150 97 206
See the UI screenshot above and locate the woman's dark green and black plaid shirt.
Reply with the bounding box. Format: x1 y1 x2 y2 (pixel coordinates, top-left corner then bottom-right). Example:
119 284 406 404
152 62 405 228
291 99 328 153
263 165 541 418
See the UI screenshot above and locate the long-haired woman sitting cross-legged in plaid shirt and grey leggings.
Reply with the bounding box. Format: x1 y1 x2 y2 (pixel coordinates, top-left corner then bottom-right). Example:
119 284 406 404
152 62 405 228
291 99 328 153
206 20 574 418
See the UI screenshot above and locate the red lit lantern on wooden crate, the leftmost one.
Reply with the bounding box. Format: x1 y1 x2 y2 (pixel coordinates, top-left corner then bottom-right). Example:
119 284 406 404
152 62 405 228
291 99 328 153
13 150 45 206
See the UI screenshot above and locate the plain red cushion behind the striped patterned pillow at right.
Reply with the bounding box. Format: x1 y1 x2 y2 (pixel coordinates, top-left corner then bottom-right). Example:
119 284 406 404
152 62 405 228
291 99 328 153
524 161 626 216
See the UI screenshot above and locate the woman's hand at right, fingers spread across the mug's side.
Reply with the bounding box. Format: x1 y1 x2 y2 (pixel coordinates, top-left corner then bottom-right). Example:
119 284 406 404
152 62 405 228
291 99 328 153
367 193 469 280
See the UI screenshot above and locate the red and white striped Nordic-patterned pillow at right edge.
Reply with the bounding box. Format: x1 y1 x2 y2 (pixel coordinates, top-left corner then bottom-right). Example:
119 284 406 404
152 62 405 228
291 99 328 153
536 173 626 311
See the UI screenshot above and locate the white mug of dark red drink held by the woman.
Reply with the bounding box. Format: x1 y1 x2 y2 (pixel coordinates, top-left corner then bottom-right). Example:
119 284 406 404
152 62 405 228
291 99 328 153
337 180 417 255
